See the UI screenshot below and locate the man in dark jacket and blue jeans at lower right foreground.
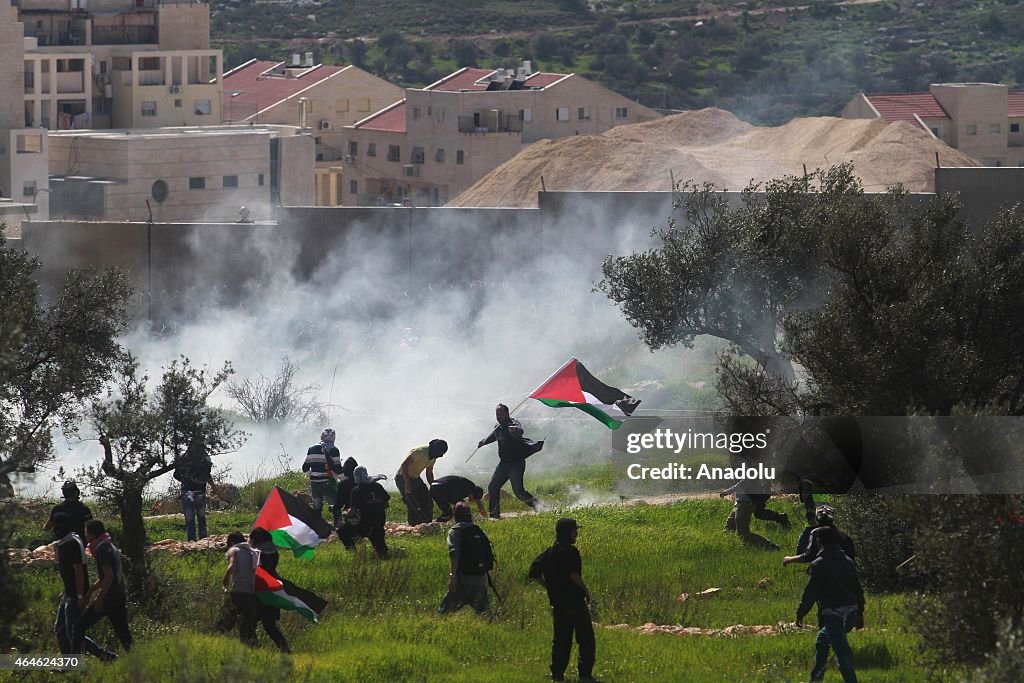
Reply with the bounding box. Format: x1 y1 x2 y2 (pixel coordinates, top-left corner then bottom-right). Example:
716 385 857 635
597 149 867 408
797 526 864 683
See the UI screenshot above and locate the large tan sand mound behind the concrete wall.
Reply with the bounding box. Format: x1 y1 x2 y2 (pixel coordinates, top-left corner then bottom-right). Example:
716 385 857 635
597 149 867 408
449 109 980 207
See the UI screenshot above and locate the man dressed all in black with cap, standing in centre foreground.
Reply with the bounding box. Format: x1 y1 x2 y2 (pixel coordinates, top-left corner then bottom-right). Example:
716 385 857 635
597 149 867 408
529 517 596 683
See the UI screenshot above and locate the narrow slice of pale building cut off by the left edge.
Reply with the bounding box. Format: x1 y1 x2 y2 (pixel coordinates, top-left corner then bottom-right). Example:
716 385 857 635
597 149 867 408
0 0 49 219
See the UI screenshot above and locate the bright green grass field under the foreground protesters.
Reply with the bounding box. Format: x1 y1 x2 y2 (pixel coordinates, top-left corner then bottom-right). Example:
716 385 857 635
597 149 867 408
8 468 937 683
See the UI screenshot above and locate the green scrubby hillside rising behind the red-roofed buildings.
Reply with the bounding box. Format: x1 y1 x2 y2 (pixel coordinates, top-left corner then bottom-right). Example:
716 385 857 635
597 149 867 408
211 0 1024 124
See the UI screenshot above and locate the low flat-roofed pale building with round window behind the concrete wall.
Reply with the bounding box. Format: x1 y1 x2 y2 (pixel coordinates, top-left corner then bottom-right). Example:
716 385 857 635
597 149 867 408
49 125 314 222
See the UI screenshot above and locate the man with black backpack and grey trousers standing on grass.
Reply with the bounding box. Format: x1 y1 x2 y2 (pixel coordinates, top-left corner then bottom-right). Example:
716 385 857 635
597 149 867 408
437 501 495 614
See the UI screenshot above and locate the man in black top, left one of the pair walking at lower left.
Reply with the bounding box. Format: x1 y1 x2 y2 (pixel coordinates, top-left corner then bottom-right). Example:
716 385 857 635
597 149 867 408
50 512 109 659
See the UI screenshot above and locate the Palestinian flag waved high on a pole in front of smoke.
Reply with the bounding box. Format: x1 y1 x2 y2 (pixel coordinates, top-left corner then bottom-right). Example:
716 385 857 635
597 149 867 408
529 358 640 429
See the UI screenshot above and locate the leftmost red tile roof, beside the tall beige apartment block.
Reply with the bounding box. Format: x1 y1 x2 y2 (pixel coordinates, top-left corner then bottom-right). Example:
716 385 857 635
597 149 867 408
222 59 347 119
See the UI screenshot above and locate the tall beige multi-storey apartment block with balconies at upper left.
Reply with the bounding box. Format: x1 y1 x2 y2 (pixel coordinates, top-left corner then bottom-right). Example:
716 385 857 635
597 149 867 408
16 0 223 130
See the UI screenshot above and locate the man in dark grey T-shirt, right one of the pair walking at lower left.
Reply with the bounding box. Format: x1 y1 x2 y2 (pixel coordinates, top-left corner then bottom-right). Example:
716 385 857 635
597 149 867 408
72 519 132 659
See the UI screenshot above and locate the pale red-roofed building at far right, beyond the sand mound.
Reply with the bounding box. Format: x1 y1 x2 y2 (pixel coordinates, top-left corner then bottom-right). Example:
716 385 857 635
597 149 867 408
842 83 1024 167
